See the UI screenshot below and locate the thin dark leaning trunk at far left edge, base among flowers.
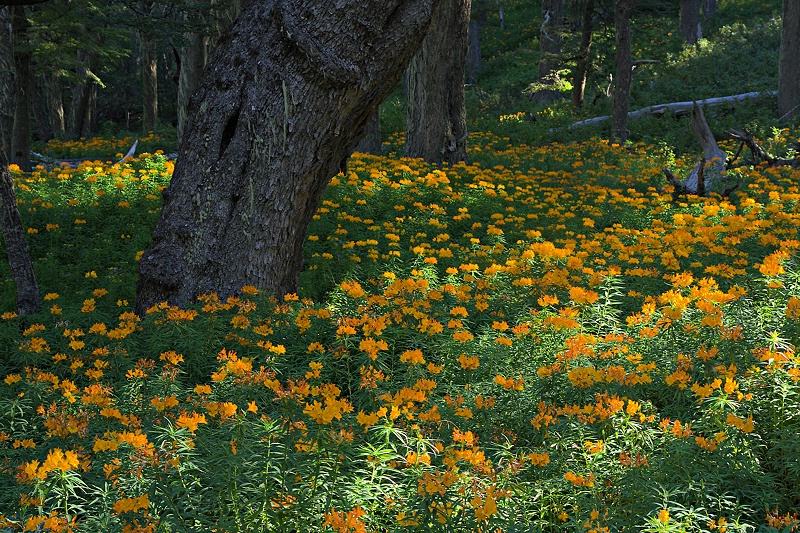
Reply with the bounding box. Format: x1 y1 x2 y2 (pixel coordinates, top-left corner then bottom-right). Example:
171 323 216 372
0 132 39 315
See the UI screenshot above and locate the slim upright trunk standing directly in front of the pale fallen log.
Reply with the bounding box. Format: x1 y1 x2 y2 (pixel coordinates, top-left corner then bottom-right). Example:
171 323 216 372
611 0 634 143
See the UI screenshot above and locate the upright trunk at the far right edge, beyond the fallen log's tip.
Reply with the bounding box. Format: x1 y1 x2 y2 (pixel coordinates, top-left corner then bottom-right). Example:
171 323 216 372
778 0 800 120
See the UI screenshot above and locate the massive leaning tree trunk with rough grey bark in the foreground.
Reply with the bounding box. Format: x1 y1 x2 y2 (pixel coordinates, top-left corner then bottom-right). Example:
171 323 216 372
136 0 437 314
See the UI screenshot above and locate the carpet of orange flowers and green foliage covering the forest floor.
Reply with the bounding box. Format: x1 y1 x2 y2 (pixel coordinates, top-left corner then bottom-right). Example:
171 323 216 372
0 0 800 533
